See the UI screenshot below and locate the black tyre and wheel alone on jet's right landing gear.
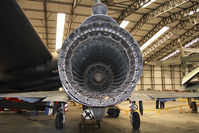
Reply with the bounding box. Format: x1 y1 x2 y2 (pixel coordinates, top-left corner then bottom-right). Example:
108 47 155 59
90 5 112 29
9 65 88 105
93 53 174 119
131 112 140 129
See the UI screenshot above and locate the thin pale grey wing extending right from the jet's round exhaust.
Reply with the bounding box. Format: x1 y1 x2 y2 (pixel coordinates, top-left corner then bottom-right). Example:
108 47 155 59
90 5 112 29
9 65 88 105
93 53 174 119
129 91 199 101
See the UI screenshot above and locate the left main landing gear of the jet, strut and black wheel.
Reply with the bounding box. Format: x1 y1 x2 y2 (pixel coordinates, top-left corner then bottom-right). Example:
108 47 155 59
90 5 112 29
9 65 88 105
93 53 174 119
55 103 66 129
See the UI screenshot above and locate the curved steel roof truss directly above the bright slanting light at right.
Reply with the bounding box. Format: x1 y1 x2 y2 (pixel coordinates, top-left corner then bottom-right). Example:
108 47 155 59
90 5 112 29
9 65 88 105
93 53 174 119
138 4 199 46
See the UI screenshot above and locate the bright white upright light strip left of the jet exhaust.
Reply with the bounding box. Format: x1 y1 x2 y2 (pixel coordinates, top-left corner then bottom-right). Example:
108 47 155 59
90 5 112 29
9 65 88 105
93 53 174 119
56 13 66 50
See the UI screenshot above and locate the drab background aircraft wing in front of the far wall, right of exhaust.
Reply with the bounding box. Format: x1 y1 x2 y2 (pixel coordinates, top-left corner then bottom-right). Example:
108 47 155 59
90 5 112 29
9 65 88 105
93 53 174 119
146 57 181 66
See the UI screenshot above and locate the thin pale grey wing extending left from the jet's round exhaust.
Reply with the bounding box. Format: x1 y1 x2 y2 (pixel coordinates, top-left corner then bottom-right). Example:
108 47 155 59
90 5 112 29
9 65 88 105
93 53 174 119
0 91 69 102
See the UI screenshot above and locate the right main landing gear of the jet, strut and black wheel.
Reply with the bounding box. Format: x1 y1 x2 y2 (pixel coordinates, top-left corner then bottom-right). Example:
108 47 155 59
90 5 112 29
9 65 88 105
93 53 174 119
130 102 140 130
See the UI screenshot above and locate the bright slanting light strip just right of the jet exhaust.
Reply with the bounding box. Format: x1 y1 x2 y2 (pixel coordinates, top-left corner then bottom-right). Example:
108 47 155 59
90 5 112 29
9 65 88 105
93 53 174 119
140 26 169 51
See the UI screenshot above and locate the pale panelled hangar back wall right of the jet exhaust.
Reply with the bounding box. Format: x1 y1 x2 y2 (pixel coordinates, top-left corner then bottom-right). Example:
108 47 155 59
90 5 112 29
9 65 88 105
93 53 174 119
136 65 182 90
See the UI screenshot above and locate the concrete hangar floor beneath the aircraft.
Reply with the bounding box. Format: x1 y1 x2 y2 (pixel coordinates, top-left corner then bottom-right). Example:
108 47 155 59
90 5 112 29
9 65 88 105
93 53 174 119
0 99 199 133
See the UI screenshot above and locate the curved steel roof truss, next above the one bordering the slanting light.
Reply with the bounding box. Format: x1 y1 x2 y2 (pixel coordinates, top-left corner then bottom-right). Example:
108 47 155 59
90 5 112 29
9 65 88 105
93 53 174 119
130 0 189 35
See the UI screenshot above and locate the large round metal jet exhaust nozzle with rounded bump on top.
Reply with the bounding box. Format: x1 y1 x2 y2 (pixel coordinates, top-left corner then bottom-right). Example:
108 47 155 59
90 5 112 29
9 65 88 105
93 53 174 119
58 3 142 107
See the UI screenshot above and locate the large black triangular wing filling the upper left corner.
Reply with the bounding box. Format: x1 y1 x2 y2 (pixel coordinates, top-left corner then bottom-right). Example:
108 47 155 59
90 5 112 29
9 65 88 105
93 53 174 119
0 0 52 72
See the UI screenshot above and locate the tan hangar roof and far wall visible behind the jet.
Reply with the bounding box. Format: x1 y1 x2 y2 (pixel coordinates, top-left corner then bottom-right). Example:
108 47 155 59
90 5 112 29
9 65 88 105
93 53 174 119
17 0 199 90
